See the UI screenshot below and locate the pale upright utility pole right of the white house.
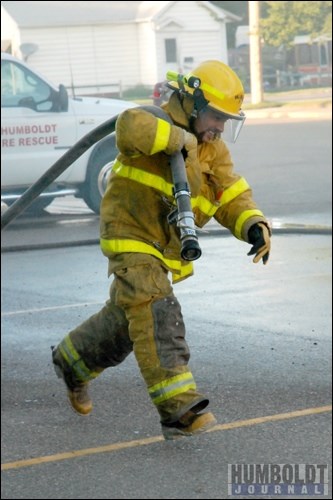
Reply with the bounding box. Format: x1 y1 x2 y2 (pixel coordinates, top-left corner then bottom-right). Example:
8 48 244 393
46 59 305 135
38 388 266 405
248 1 263 104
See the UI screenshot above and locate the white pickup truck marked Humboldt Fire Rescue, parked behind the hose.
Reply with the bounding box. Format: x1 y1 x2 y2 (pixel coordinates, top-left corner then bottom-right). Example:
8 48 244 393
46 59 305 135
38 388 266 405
1 53 136 213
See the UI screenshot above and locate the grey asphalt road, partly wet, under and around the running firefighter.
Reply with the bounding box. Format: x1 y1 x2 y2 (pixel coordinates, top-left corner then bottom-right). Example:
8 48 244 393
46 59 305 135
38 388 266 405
1 116 332 499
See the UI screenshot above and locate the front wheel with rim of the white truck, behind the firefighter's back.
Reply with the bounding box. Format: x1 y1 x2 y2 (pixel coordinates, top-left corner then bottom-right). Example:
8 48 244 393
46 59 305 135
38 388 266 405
82 143 118 214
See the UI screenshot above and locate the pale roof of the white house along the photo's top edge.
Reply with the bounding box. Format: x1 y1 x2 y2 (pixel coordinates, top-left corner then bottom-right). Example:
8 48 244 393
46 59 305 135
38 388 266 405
1 0 240 28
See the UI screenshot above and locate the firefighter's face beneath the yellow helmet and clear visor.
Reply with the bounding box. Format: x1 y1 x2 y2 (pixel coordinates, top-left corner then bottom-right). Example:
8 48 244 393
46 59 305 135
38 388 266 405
193 107 228 143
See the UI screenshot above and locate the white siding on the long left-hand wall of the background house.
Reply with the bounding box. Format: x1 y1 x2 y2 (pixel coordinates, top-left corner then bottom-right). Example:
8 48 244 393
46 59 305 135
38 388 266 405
22 24 140 94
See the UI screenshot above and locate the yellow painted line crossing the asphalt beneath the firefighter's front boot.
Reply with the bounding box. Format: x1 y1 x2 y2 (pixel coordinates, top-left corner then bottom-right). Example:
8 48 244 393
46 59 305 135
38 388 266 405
1 405 332 470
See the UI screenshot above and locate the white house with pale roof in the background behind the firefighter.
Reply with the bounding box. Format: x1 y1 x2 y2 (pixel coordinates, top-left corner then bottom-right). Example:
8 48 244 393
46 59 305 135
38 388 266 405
1 0 240 93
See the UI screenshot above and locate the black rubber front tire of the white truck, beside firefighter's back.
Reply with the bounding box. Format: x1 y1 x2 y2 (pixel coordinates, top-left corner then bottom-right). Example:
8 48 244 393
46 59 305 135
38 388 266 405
82 136 118 214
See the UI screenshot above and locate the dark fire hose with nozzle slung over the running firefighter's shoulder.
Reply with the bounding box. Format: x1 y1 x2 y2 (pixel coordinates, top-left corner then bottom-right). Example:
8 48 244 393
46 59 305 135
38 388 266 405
1 106 201 261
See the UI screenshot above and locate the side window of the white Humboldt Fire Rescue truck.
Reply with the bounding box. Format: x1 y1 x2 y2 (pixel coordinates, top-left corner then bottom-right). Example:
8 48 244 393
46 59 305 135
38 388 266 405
1 61 54 112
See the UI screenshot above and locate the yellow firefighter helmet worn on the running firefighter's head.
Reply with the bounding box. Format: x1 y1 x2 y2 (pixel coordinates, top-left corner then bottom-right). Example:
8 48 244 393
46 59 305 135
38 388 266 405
167 61 244 120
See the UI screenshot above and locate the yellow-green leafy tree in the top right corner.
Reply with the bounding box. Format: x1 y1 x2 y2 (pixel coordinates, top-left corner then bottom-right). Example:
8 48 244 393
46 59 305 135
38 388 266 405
260 1 332 47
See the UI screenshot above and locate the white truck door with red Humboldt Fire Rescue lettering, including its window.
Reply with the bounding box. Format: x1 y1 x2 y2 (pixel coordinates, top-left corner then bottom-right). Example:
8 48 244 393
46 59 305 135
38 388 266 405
1 56 77 187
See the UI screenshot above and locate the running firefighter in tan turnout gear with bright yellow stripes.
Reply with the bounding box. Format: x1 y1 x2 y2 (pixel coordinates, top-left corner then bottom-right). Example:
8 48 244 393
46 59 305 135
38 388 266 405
52 61 271 439
